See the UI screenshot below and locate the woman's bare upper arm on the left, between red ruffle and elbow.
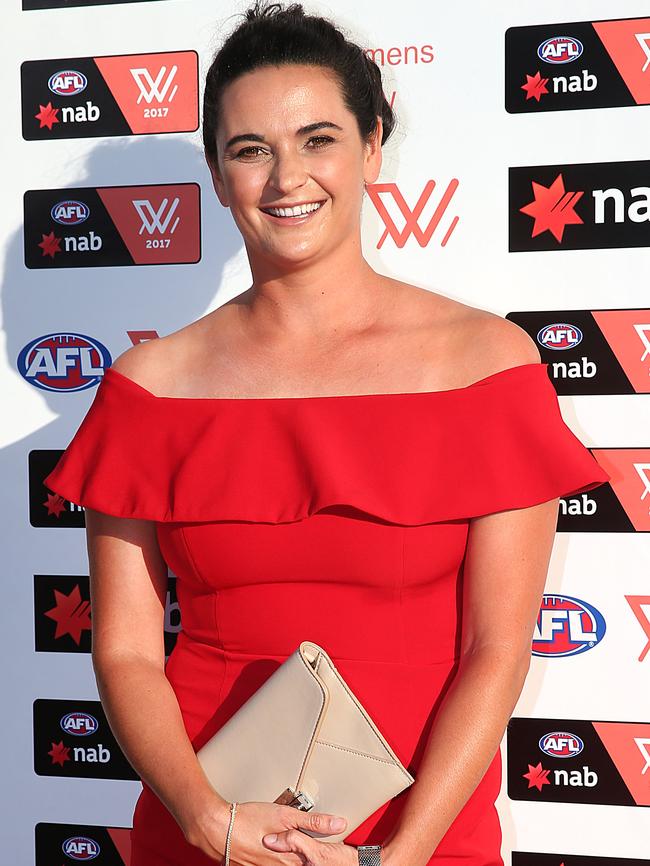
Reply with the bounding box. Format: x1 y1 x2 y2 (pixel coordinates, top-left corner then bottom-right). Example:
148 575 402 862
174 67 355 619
85 508 167 668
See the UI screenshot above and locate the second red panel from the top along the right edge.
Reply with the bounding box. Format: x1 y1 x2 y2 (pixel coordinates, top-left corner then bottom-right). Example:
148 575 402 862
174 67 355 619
592 308 650 394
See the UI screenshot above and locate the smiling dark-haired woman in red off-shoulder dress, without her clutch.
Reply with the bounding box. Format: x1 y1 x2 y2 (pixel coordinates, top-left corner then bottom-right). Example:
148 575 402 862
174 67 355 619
47 4 609 866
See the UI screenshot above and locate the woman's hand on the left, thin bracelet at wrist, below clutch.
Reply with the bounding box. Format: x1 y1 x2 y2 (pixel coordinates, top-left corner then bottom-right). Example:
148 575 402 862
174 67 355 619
185 801 347 866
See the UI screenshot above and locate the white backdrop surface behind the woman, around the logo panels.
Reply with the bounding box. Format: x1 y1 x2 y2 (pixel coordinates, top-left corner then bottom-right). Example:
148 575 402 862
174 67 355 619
0 0 650 864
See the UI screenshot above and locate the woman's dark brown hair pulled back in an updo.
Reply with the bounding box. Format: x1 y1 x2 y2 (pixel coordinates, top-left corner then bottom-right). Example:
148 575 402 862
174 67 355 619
202 0 395 165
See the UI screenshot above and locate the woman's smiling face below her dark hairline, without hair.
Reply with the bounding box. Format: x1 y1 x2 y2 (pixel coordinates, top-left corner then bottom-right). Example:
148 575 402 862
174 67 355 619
210 64 381 267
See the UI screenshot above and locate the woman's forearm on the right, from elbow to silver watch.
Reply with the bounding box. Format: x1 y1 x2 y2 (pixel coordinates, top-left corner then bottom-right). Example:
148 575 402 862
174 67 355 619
383 649 528 866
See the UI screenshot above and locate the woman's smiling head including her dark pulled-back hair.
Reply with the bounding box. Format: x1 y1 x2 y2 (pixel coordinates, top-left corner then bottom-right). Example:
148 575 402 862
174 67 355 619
203 5 394 277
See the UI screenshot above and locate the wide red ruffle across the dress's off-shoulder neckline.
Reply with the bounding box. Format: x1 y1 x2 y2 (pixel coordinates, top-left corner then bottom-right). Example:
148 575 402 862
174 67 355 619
45 363 610 525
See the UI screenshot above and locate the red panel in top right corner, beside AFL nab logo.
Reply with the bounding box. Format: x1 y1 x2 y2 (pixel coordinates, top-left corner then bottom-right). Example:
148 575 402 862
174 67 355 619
593 18 650 105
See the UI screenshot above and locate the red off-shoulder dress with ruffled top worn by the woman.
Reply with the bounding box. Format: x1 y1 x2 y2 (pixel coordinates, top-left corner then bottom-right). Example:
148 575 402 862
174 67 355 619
45 363 610 866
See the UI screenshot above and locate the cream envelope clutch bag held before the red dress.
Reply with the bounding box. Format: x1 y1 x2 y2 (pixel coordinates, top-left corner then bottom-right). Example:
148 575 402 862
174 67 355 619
197 640 415 842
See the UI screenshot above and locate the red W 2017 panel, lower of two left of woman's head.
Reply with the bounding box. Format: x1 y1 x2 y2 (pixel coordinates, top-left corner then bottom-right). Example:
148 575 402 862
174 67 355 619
97 183 201 265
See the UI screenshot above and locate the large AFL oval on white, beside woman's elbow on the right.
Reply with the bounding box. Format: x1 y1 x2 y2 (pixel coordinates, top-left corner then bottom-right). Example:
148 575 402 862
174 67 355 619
532 595 606 658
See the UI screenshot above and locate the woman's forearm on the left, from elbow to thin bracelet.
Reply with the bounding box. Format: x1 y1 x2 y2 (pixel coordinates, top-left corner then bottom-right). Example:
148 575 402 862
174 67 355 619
95 657 228 832
